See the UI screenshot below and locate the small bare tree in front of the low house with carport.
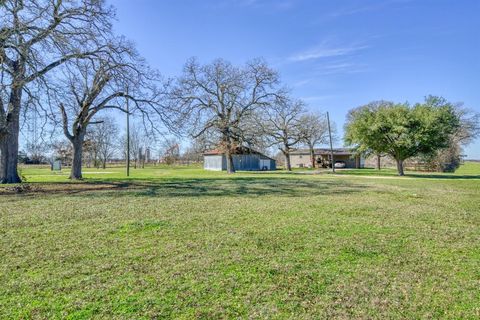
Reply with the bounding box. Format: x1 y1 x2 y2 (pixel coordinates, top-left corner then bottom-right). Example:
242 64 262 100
299 113 328 168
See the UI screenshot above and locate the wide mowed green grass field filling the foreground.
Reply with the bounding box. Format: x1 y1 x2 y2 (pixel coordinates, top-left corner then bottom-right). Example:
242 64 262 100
0 163 480 319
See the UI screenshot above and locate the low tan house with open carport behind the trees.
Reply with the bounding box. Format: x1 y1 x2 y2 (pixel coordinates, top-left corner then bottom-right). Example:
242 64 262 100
290 148 365 168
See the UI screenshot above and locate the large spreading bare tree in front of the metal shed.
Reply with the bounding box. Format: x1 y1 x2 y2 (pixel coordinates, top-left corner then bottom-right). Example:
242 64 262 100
171 59 279 173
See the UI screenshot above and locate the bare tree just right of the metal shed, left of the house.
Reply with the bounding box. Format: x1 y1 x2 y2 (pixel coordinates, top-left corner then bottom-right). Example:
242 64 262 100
258 97 305 171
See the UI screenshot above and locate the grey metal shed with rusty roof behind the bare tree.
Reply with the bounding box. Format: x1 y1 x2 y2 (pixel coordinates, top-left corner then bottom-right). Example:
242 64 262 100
203 147 277 171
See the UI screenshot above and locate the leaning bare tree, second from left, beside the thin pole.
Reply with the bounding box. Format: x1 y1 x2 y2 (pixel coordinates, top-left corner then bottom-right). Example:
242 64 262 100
55 42 164 179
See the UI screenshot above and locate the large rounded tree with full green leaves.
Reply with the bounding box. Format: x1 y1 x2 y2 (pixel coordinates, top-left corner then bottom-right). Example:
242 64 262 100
345 96 460 176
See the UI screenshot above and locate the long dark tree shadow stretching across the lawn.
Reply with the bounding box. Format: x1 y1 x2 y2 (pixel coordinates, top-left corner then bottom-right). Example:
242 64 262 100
0 177 368 197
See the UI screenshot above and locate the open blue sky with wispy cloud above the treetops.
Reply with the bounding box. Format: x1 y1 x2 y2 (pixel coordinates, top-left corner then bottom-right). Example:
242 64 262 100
110 0 480 159
